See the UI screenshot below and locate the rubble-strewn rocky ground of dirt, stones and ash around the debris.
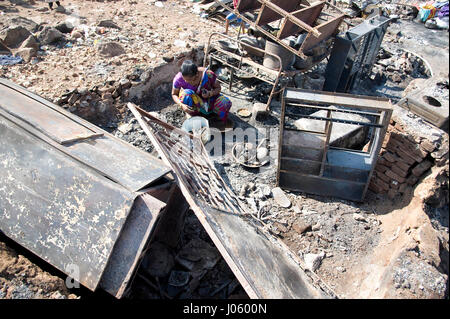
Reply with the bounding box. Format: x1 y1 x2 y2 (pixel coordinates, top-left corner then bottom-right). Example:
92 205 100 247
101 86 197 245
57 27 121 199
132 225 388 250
0 0 448 299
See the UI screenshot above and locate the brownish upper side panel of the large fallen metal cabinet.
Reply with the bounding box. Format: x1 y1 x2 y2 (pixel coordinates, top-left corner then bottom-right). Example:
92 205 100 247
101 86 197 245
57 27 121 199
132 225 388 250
0 79 170 191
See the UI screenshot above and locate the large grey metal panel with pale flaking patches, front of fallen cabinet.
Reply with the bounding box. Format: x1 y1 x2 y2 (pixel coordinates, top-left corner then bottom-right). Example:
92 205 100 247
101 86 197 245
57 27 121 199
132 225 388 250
0 116 135 290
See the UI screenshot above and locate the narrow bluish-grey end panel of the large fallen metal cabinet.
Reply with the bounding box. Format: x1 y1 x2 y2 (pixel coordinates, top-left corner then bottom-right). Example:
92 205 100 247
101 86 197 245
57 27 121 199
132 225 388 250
100 194 166 298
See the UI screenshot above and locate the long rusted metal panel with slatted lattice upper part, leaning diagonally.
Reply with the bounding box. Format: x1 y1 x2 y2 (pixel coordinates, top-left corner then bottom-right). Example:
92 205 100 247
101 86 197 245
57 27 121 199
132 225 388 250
128 103 333 298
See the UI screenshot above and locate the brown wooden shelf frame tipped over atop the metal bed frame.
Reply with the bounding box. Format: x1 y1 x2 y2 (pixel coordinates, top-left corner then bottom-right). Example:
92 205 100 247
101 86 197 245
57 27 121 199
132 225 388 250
214 0 345 58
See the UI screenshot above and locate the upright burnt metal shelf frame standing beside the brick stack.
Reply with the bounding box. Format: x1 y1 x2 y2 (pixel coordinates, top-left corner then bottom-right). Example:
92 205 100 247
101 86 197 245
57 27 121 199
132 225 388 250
277 88 392 201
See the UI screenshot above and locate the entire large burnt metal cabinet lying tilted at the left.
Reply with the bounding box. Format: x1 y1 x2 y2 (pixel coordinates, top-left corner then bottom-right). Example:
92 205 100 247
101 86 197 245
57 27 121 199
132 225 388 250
0 79 170 297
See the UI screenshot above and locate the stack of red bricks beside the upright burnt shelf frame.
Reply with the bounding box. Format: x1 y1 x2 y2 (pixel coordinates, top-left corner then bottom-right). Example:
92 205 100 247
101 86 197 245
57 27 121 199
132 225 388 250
369 121 436 198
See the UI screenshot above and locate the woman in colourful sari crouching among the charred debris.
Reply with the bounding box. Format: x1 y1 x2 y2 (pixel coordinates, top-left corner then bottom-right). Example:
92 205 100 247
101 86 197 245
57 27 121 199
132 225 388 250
172 60 231 122
